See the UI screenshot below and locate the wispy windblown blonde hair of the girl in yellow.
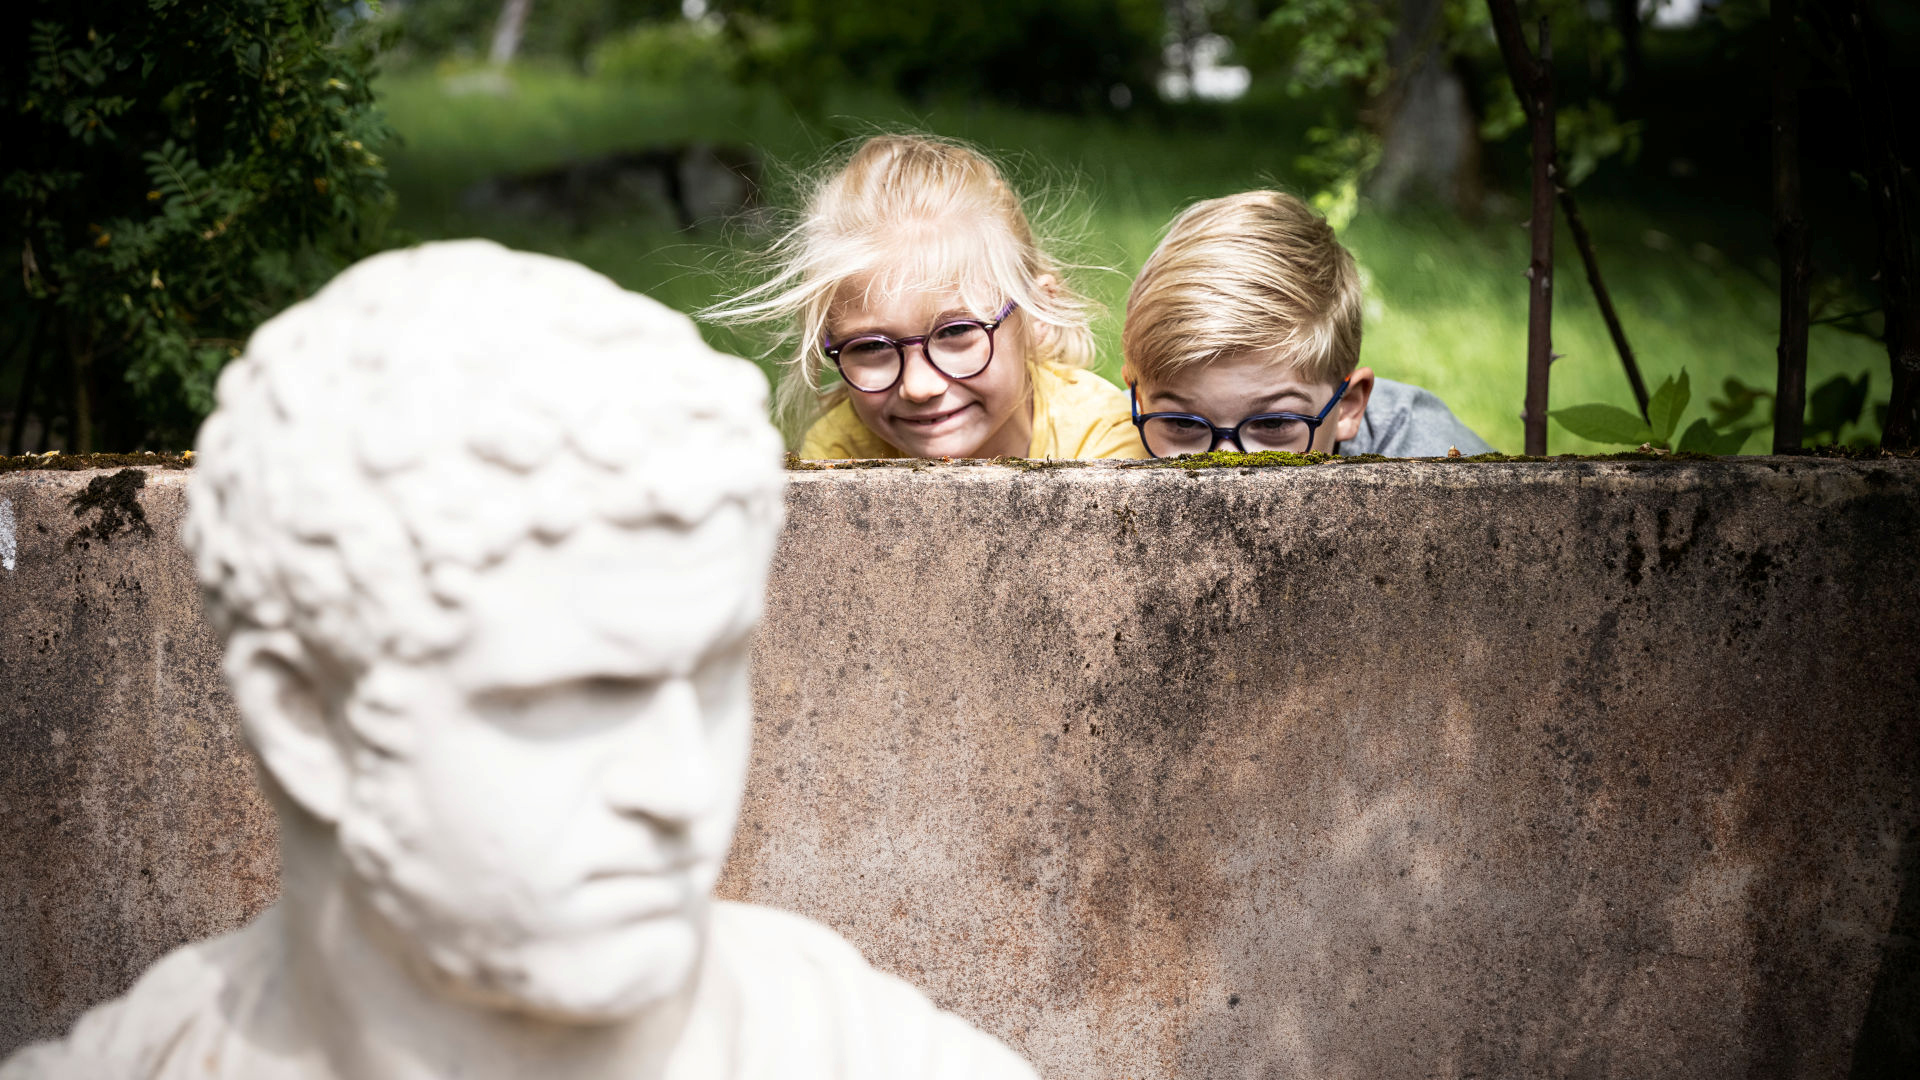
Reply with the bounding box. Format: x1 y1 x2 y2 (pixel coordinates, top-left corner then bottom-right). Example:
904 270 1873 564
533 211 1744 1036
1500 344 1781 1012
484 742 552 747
703 135 1094 432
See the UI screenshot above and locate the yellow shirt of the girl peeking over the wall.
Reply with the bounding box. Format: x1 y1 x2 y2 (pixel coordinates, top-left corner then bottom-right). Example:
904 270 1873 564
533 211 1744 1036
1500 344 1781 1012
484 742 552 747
801 361 1146 459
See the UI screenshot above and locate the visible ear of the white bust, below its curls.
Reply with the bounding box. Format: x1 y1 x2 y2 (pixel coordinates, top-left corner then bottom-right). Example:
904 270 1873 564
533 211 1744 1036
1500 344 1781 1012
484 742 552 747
227 630 348 824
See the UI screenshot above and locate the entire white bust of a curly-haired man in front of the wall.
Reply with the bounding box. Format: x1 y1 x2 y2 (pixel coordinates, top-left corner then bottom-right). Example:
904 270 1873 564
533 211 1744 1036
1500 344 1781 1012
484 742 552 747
0 242 1033 1080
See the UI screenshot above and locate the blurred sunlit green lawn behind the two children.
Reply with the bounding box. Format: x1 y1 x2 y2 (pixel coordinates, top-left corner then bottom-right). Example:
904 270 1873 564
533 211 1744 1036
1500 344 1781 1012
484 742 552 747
382 69 1887 454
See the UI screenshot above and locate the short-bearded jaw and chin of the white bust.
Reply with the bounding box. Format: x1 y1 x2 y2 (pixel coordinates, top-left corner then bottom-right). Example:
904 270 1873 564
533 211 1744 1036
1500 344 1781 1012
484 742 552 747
338 761 712 1024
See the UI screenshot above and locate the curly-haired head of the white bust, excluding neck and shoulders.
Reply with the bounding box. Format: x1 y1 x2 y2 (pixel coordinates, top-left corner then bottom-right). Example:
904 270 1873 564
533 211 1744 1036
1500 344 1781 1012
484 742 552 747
186 242 783 1022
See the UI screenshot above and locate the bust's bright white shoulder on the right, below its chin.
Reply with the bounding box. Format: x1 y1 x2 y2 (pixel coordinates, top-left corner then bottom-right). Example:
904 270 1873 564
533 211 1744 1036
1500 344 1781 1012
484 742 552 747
712 901 1035 1080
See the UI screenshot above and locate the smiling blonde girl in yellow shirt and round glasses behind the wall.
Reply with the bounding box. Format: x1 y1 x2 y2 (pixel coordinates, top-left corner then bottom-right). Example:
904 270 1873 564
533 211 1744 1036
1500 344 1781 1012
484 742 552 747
708 135 1146 457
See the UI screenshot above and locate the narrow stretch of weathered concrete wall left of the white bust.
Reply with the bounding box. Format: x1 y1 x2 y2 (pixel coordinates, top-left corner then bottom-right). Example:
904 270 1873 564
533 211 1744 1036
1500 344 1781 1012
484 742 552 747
0 469 278 1053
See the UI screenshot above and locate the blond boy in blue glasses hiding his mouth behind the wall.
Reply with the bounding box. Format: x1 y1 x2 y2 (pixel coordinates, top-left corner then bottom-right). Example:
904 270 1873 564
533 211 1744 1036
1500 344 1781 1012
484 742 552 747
1121 190 1492 457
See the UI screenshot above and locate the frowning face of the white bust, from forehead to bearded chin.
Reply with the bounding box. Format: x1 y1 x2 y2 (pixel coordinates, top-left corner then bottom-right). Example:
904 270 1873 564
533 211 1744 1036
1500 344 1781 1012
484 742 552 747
340 505 774 1022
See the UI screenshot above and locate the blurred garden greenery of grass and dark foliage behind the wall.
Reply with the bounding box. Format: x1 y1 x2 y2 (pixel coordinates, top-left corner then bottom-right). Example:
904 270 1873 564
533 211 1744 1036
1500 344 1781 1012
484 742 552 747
0 0 1920 450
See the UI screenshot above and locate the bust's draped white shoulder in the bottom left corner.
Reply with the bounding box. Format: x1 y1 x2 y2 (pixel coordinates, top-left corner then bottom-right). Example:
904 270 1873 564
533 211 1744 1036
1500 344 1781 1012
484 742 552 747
0 907 278 1080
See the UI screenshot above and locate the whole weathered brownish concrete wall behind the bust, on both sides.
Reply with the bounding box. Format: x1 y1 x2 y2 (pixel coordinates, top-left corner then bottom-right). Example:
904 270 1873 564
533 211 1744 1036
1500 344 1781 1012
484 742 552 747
0 459 1920 1078
